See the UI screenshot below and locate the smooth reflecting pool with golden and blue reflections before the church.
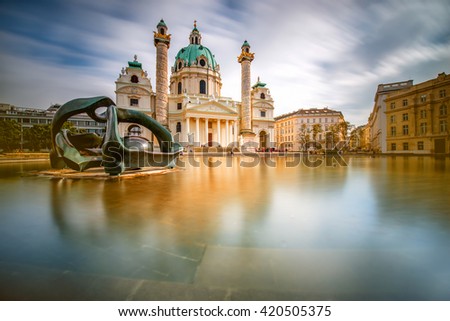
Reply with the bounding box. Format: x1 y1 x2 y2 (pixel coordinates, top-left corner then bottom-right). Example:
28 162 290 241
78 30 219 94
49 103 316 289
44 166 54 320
0 156 450 300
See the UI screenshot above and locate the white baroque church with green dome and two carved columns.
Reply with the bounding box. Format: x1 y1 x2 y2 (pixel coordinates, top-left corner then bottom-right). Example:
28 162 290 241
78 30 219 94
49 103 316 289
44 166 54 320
116 19 275 149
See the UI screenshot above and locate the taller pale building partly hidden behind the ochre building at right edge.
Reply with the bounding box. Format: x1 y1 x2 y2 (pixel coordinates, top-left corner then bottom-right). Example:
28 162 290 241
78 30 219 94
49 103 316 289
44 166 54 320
368 80 413 153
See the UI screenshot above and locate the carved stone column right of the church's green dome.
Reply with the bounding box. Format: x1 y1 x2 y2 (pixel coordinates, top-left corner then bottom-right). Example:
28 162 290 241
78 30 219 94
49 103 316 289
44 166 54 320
238 40 255 144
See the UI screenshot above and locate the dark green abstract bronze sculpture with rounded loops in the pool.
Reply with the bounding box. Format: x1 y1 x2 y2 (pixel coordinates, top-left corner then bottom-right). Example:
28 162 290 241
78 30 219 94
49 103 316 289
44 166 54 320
50 96 182 175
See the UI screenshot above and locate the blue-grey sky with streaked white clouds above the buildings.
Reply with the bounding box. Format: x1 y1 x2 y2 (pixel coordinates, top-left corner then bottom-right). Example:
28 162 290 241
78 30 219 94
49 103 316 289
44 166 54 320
0 0 450 125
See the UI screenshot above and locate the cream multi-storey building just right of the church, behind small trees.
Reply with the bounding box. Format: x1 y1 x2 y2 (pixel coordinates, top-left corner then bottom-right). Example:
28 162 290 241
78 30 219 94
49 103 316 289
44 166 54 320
275 107 347 151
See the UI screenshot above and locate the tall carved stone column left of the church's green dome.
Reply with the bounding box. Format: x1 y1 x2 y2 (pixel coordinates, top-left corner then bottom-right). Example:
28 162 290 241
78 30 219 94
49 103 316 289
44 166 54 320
154 19 170 128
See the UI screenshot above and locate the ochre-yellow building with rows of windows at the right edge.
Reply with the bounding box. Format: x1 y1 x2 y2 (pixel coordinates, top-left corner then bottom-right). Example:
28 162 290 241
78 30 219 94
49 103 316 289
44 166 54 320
385 72 450 154
